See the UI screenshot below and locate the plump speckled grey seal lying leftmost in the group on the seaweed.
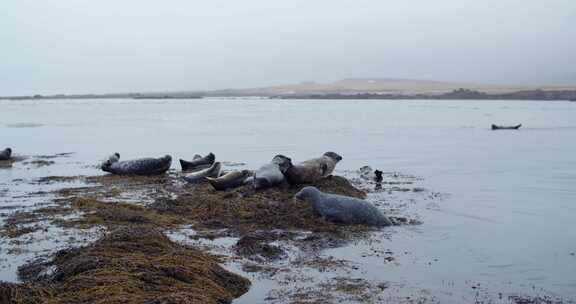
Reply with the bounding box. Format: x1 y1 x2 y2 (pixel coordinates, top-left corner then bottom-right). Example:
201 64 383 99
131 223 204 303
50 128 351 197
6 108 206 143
101 153 172 175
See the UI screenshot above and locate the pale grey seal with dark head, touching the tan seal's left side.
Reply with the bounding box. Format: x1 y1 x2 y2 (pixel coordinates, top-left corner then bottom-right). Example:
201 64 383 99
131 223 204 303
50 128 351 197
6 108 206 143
246 154 292 189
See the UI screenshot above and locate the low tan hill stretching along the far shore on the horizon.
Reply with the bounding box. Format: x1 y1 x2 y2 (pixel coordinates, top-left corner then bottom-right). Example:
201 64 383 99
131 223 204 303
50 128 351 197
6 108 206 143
0 78 576 100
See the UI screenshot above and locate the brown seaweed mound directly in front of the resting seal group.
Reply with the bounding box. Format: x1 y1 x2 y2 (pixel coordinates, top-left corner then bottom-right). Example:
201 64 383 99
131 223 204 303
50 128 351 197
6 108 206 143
149 176 366 232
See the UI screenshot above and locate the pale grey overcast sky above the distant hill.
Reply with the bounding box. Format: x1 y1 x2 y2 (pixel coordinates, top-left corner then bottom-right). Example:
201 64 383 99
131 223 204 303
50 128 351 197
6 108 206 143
0 0 576 95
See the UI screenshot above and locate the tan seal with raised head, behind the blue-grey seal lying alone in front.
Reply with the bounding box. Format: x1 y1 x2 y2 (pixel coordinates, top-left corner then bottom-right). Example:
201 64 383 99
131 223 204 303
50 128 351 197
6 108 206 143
285 152 342 185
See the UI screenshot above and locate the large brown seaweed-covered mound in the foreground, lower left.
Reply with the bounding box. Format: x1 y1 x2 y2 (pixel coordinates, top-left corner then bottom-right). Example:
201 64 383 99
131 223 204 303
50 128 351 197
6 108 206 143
14 226 250 304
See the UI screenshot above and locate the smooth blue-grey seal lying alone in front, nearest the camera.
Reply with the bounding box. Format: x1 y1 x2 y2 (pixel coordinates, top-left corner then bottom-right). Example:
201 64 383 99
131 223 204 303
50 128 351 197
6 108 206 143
294 186 392 227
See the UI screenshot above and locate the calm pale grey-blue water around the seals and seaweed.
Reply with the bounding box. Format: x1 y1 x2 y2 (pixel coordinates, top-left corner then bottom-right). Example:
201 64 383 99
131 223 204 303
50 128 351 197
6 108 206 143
0 99 576 302
